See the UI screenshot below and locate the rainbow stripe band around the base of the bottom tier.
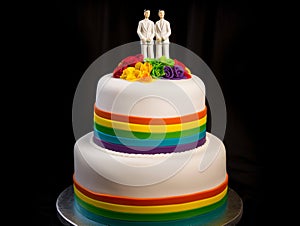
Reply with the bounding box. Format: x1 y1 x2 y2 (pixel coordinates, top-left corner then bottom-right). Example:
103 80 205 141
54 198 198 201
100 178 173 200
74 177 228 222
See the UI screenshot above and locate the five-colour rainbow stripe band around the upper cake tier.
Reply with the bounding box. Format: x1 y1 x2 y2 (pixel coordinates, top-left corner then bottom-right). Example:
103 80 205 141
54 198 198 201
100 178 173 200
93 106 207 154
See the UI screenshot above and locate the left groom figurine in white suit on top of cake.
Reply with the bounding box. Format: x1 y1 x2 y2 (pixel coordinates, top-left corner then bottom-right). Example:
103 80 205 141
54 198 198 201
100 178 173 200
137 9 155 58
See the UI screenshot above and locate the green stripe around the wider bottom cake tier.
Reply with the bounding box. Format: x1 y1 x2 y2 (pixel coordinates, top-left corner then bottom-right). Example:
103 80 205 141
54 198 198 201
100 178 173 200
74 194 227 221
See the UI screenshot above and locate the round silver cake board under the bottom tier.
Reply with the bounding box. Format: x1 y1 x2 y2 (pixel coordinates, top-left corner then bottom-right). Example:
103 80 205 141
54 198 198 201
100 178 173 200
56 186 243 226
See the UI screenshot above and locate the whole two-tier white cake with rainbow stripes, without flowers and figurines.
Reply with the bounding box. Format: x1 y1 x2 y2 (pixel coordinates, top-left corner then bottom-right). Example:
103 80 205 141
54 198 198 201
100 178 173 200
73 57 228 225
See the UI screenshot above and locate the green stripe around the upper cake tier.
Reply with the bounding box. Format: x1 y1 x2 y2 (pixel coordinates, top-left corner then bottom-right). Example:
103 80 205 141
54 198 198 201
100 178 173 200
94 122 206 139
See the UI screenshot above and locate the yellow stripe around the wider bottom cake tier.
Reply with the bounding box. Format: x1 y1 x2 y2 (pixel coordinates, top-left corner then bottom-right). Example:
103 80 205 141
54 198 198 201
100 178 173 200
74 186 228 214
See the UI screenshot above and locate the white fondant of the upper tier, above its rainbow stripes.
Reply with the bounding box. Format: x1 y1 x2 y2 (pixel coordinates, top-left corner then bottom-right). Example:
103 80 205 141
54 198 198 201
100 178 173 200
95 74 205 118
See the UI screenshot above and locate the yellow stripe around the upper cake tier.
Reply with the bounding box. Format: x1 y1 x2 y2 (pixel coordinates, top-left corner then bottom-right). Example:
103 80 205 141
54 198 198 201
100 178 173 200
94 114 206 133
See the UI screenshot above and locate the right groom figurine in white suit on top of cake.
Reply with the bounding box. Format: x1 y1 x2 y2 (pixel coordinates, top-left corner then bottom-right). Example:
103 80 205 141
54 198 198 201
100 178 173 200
155 9 171 59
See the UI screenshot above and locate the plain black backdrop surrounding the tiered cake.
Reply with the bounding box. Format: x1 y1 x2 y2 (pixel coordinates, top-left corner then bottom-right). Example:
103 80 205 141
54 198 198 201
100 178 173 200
3 0 292 225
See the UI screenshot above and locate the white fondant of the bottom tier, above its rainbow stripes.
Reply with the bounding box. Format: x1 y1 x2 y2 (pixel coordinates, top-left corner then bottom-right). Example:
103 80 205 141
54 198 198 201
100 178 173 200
74 132 226 197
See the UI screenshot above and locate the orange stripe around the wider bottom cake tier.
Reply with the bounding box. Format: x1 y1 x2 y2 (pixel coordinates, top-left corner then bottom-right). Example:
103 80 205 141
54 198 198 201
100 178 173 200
73 174 228 206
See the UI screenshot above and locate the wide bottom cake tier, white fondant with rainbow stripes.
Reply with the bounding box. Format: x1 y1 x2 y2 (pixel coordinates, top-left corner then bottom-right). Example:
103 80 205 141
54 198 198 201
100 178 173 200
73 133 228 225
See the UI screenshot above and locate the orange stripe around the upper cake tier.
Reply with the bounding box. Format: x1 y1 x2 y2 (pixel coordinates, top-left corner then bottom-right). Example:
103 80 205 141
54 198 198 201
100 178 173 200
94 104 207 125
